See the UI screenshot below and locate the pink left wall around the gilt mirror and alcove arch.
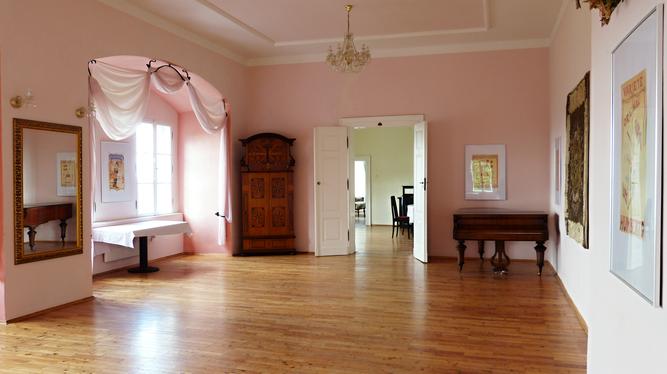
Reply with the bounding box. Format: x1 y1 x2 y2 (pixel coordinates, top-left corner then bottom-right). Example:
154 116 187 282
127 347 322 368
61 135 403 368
0 0 247 319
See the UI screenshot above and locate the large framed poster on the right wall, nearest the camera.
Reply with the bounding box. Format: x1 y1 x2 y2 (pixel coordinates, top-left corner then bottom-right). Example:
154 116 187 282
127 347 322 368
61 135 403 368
610 5 663 306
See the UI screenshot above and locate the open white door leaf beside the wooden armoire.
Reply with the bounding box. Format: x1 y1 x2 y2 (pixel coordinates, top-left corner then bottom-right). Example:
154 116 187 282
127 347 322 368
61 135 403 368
313 127 354 256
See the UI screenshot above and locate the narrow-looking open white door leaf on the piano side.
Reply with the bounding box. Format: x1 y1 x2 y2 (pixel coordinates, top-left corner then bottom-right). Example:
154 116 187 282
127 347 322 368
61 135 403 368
412 122 428 262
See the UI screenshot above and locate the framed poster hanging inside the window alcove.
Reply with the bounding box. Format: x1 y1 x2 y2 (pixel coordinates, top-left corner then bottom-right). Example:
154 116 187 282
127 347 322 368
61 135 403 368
100 142 136 203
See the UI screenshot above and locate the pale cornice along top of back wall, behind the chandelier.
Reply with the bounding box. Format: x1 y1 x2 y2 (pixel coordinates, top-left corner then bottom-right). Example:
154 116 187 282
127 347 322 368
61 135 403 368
246 39 550 66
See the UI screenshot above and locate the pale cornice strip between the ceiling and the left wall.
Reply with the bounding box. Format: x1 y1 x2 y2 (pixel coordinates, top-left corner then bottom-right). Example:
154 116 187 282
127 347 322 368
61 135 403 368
98 0 246 65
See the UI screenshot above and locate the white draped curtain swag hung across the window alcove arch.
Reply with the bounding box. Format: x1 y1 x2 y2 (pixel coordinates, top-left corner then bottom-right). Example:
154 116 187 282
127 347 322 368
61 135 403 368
89 61 232 245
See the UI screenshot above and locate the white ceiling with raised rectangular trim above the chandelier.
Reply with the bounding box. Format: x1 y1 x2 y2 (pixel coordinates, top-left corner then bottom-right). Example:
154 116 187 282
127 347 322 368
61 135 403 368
99 0 572 66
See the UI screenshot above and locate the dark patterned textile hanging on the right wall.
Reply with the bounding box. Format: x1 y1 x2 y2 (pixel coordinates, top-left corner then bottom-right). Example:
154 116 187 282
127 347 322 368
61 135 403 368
564 73 590 248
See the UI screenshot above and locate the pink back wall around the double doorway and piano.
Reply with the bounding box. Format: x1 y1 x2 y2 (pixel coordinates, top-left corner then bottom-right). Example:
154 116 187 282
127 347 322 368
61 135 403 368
246 49 550 258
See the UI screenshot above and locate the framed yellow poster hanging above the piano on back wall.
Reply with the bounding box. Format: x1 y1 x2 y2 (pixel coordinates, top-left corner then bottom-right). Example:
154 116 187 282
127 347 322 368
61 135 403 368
465 144 507 200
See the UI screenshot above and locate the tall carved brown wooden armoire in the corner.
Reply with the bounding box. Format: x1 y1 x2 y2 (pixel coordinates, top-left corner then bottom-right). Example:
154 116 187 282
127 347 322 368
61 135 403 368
240 133 296 255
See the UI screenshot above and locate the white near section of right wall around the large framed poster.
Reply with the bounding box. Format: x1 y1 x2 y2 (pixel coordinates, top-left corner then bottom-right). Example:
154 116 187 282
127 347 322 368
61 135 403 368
585 0 667 373
